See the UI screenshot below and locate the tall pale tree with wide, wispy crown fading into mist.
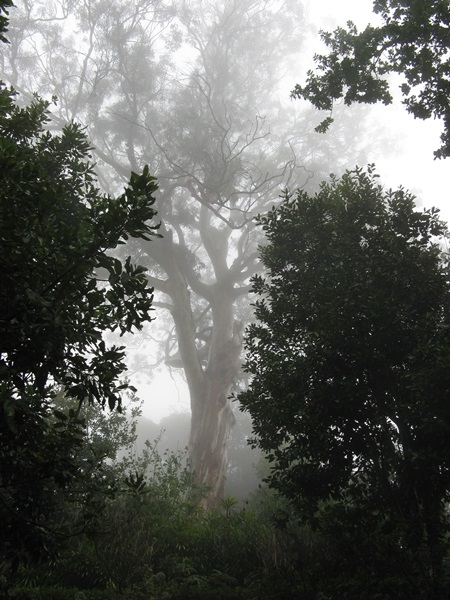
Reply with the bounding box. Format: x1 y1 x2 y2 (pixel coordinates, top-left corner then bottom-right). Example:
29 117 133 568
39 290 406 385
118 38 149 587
7 0 366 504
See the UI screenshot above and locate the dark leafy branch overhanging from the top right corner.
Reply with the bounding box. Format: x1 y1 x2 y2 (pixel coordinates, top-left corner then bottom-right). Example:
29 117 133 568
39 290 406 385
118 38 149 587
292 0 450 158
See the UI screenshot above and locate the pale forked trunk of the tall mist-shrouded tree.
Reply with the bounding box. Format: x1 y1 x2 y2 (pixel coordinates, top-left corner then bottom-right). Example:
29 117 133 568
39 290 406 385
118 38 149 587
156 225 242 508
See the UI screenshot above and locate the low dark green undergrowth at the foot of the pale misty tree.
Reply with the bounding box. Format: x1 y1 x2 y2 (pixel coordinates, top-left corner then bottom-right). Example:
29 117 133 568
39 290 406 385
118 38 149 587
9 413 384 600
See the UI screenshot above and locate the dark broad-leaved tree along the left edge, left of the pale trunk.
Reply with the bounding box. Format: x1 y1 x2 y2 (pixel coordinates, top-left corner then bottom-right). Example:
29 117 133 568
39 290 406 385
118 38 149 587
0 84 161 564
